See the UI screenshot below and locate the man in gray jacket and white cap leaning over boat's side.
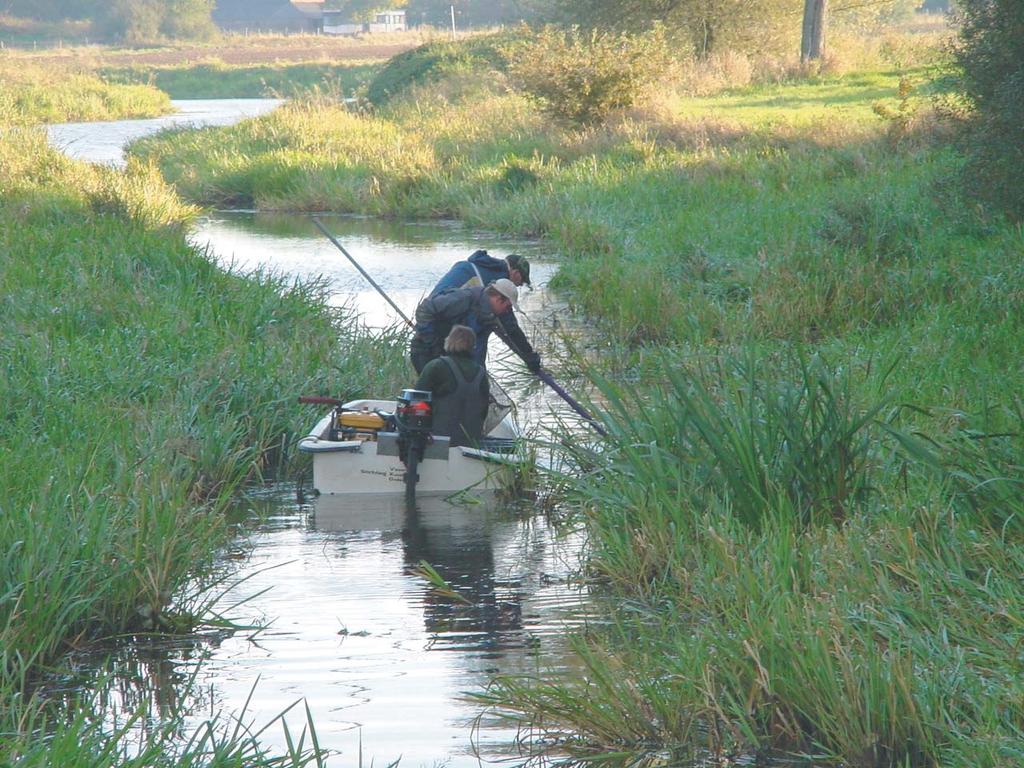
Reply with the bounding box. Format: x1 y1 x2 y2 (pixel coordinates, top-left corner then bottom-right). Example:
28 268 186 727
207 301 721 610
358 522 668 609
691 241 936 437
409 278 541 373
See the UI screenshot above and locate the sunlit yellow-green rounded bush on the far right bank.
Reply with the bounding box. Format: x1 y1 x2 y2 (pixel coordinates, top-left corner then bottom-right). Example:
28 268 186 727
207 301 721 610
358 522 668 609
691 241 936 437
507 27 671 125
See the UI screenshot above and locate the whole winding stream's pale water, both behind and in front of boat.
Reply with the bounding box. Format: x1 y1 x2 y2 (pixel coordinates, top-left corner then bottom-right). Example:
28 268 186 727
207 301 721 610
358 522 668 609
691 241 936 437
51 101 585 768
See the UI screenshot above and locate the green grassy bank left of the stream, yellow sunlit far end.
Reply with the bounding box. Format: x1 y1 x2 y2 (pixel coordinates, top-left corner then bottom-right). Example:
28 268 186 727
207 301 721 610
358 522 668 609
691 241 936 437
0 129 404 765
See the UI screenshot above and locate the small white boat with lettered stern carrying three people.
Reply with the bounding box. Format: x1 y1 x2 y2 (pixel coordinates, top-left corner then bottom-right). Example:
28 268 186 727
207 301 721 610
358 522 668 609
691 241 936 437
299 399 520 497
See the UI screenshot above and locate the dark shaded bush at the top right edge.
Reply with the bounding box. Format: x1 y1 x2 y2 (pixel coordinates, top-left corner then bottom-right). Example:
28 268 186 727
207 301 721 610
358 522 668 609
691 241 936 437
955 0 1024 220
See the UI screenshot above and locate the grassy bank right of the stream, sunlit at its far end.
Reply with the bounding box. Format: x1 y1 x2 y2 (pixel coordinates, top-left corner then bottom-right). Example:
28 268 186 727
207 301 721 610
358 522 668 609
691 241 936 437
125 13 1024 768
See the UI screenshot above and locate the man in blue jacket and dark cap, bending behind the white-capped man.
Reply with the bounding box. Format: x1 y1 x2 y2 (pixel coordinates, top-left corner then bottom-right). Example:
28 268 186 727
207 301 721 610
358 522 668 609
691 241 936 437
423 251 541 374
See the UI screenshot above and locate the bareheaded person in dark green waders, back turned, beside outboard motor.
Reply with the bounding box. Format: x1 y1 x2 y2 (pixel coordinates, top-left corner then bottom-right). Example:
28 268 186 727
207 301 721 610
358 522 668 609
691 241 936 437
414 326 490 446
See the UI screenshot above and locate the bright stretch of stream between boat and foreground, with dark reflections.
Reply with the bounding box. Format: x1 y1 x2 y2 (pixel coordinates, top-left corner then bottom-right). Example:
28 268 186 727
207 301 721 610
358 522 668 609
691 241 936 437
167 489 583 768
